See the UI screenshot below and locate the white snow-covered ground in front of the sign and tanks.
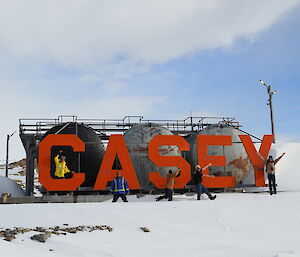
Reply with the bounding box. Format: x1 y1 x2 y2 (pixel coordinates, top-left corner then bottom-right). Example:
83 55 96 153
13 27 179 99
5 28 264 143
0 143 300 257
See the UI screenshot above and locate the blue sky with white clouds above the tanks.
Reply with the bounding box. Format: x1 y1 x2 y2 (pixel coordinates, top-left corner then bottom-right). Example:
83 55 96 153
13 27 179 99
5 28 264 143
0 0 300 160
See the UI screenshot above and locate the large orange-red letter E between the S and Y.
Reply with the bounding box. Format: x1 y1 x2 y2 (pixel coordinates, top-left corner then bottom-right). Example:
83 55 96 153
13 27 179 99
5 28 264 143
197 135 235 187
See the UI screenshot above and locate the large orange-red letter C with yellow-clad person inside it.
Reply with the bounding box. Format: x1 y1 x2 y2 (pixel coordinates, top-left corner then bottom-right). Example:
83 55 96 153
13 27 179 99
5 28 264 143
38 134 85 191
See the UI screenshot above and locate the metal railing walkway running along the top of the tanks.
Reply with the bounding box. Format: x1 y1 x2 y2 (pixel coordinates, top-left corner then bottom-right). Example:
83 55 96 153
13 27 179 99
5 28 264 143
19 115 240 136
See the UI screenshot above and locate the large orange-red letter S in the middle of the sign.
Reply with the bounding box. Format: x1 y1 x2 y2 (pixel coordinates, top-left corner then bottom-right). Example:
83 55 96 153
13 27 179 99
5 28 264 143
148 135 191 188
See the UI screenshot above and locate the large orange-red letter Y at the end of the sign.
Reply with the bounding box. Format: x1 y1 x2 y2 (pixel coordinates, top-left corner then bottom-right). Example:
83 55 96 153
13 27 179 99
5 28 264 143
239 135 273 187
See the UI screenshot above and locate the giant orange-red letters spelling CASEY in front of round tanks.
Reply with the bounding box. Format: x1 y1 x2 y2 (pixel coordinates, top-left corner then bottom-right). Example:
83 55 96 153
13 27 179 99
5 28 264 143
38 134 273 191
